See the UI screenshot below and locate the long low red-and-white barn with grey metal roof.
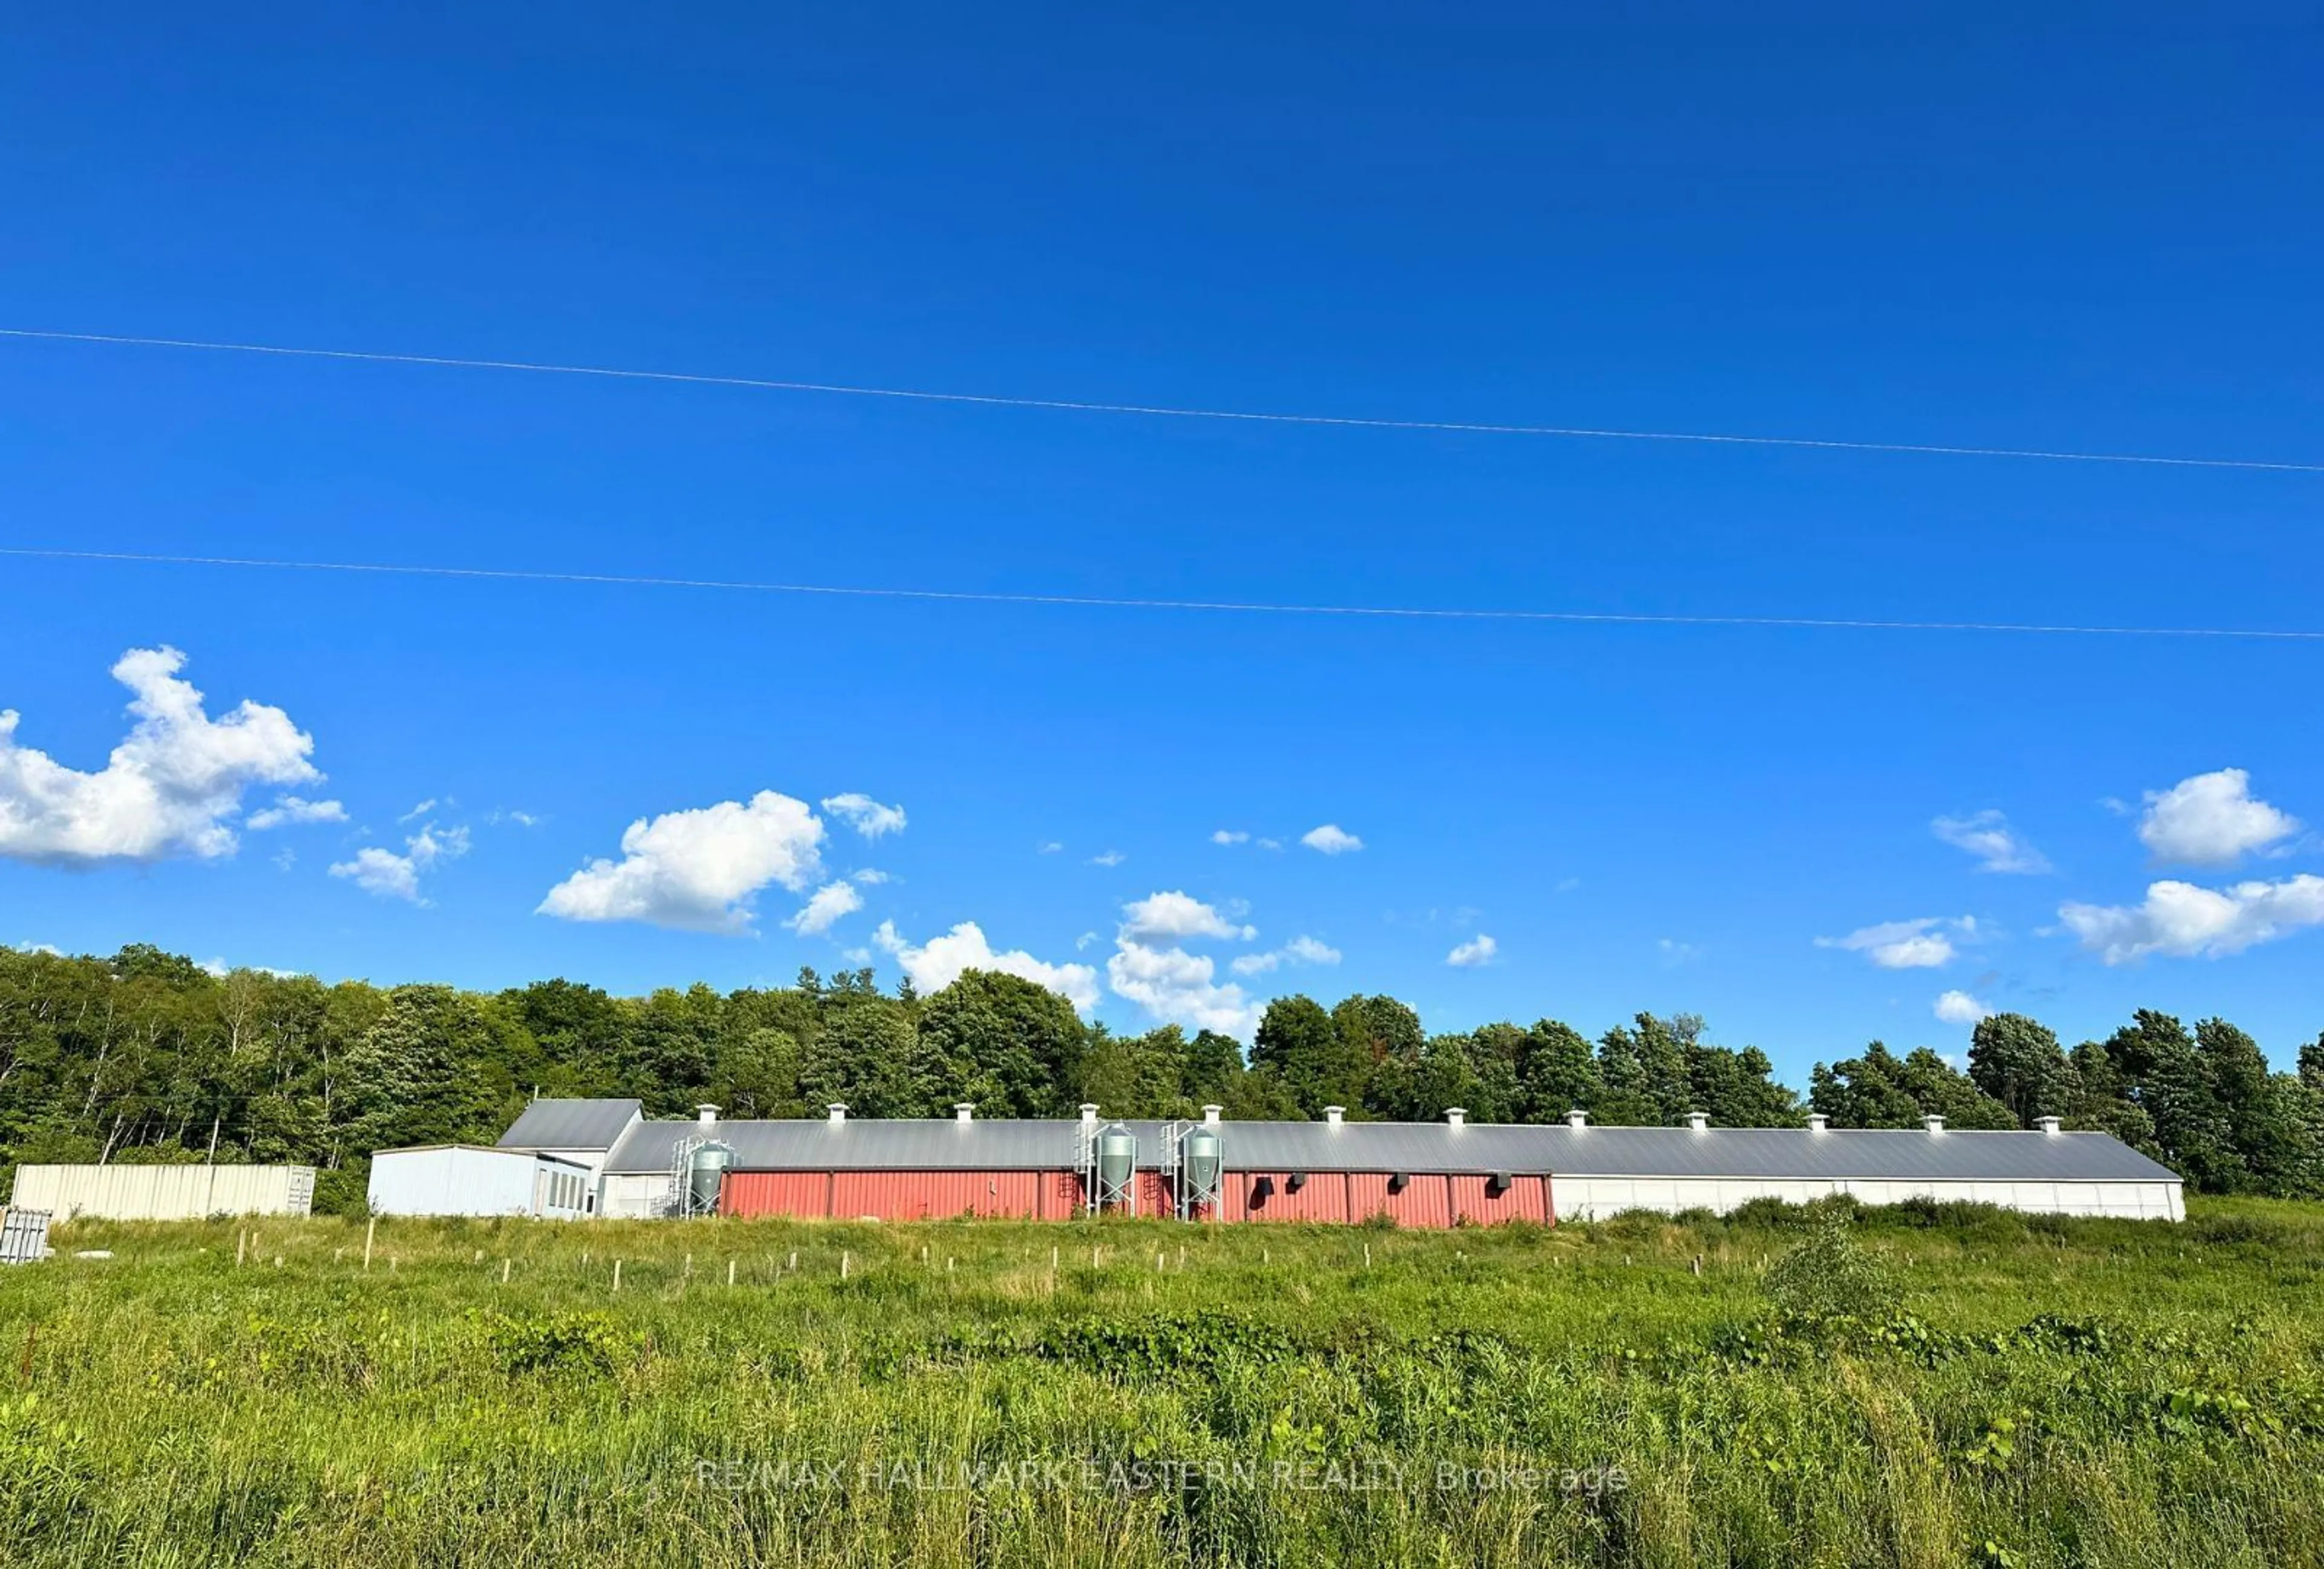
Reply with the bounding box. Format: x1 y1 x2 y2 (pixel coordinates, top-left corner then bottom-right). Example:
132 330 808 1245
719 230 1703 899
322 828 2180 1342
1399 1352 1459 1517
467 1102 2185 1228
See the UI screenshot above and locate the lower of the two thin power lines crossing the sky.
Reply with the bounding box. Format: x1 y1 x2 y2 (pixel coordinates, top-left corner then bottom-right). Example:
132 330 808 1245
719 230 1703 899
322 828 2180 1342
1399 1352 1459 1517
0 546 2324 642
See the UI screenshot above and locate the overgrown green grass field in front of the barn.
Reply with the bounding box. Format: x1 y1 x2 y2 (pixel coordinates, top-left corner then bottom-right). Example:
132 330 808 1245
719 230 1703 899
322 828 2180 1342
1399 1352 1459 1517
0 1202 2324 1569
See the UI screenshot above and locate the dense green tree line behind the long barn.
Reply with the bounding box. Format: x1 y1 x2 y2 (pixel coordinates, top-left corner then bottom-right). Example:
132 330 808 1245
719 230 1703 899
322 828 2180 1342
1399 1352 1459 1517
0 946 2324 1211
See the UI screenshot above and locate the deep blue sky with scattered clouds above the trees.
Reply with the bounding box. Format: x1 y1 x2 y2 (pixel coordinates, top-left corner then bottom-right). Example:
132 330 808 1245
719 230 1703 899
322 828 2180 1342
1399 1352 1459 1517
0 7 2324 1079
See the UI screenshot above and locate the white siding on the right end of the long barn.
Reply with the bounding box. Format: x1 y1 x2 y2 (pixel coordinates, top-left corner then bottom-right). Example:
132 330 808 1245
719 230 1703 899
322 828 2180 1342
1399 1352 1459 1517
1550 1176 2187 1220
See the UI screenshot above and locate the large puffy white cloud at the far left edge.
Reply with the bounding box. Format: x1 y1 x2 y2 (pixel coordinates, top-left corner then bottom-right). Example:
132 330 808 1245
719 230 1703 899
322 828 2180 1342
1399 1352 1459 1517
0 648 323 867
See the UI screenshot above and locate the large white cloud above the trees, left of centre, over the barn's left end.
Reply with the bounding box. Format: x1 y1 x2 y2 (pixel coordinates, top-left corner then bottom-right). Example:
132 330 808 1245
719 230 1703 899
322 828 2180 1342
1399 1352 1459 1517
537 791 822 935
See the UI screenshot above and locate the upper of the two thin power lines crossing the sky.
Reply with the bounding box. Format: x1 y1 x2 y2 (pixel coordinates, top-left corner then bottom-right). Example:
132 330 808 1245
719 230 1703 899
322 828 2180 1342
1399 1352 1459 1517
0 327 2324 474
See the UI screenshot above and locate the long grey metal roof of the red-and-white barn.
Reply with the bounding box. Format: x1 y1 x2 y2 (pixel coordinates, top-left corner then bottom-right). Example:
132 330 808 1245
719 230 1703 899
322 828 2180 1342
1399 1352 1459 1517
599 1118 2178 1183
